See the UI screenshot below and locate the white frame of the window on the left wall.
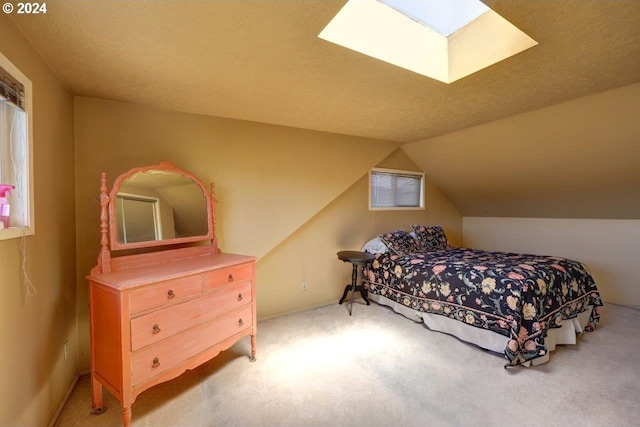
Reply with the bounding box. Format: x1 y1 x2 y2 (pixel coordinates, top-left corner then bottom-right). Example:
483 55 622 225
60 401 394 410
0 52 35 240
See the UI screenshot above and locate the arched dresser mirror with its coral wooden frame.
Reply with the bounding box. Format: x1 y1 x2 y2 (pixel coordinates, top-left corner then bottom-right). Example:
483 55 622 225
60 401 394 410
109 162 213 250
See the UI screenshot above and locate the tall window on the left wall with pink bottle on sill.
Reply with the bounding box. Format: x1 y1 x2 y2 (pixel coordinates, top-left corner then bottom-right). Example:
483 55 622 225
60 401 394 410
0 53 34 240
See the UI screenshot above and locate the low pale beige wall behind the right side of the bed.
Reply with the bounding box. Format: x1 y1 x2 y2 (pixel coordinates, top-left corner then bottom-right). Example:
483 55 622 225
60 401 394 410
463 217 640 305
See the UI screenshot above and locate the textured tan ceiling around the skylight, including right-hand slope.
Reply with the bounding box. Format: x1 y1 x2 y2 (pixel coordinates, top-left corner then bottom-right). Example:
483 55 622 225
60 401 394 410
10 0 640 219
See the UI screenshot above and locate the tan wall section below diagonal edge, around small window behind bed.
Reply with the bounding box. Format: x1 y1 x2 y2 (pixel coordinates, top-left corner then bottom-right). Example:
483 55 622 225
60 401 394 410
257 149 462 317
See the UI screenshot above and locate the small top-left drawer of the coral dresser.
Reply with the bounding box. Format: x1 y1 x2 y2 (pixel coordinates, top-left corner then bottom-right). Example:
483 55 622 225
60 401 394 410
129 275 202 313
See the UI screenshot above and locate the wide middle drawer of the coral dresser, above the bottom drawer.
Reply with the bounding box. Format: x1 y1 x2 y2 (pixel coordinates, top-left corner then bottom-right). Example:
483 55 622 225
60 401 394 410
131 282 253 351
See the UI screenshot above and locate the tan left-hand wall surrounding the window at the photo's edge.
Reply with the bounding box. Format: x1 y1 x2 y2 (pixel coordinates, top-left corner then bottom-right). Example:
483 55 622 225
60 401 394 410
0 14 78 426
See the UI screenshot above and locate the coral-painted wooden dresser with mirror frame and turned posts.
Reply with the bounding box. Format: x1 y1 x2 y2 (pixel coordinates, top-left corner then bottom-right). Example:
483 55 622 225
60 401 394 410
88 163 256 427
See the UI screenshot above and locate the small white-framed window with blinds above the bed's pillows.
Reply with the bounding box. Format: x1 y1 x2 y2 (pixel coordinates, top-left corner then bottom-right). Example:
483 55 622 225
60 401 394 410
369 168 424 210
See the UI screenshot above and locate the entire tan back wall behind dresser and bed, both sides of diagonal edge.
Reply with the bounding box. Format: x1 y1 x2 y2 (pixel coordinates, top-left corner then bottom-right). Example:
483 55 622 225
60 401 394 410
75 97 462 369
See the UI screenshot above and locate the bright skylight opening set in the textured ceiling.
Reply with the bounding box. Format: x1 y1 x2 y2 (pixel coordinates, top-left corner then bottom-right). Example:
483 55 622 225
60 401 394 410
318 0 537 83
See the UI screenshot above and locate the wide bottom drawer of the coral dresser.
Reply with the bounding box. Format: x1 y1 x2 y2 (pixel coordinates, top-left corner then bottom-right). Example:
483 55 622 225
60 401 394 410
131 305 253 386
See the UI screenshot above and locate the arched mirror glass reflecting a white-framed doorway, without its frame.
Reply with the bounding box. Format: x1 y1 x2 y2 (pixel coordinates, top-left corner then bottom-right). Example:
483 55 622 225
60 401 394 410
116 170 208 243
